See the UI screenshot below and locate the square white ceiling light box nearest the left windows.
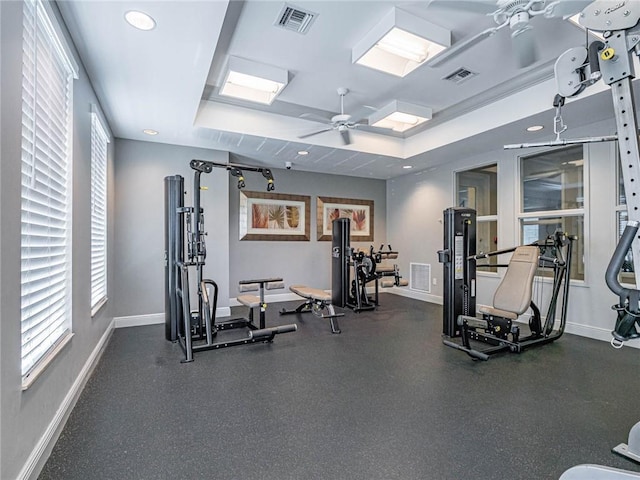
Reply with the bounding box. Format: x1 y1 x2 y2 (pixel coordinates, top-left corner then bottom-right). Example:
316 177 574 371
218 57 289 105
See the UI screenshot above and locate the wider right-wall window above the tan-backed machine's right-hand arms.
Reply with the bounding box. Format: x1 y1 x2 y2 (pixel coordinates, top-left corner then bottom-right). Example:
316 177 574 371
520 145 585 280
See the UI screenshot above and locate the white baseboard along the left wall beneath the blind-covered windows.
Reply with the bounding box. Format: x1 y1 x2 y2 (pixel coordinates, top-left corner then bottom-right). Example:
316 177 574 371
17 321 115 480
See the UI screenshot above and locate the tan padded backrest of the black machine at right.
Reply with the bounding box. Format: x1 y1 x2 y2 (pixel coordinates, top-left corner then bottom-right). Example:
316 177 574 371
493 245 540 315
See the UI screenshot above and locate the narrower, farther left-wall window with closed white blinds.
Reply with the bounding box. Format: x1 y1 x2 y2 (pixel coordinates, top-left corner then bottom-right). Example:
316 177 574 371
91 111 109 315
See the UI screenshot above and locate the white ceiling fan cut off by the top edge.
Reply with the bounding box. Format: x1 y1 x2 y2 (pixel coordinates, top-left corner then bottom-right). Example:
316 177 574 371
430 0 593 68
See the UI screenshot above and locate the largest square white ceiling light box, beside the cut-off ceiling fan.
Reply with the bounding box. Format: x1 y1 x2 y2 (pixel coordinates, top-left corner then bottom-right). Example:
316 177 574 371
351 8 451 77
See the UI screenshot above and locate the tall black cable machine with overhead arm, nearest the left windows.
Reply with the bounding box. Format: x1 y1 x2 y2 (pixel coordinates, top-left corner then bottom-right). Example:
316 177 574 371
164 160 297 362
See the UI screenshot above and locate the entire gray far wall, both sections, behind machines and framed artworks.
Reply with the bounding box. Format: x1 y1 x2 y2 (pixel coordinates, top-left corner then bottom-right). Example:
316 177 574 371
113 146 387 317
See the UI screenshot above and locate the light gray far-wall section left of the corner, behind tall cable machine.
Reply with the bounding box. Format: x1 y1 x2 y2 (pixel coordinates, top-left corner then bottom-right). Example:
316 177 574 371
114 139 229 317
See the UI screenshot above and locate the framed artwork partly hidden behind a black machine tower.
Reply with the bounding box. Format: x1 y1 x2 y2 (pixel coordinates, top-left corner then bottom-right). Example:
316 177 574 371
316 197 373 242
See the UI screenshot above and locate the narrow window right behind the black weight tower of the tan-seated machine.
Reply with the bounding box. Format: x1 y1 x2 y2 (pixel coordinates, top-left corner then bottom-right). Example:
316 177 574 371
456 163 498 272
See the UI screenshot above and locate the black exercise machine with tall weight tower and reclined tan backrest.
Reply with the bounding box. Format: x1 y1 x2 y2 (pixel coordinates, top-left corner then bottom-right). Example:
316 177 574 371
438 207 576 360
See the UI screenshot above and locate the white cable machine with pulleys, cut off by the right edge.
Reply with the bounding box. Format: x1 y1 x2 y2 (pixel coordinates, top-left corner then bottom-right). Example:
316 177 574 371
504 0 640 480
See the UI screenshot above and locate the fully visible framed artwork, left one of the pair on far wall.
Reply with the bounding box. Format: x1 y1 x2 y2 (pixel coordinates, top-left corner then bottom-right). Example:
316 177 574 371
239 191 311 241
